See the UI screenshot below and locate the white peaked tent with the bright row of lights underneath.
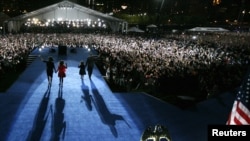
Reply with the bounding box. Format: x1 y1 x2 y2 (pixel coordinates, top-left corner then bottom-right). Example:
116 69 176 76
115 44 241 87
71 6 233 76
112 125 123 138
4 0 128 32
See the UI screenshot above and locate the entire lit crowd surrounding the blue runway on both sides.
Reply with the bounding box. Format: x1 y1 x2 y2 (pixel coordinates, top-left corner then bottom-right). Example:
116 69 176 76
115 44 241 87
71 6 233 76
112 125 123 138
0 32 250 100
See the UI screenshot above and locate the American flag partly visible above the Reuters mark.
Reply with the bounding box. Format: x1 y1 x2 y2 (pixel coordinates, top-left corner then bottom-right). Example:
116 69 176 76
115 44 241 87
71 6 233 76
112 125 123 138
226 73 250 125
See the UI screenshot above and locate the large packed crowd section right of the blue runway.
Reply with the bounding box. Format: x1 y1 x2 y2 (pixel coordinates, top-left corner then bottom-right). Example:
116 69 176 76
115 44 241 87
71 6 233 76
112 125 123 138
92 33 250 97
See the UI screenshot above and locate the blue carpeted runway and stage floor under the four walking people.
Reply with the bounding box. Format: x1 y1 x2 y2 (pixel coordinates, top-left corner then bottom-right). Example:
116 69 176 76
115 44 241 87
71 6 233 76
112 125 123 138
0 48 234 141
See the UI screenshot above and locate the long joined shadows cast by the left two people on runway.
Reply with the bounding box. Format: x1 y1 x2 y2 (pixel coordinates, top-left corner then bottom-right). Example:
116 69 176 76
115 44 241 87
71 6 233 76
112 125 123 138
27 85 66 141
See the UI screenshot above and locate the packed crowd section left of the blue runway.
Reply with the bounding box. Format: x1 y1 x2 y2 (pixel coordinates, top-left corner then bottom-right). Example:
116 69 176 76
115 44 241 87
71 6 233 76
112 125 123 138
0 34 34 78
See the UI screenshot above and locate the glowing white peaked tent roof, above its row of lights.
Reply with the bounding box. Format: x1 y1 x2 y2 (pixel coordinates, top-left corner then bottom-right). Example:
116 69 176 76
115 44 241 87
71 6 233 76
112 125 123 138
5 0 127 32
